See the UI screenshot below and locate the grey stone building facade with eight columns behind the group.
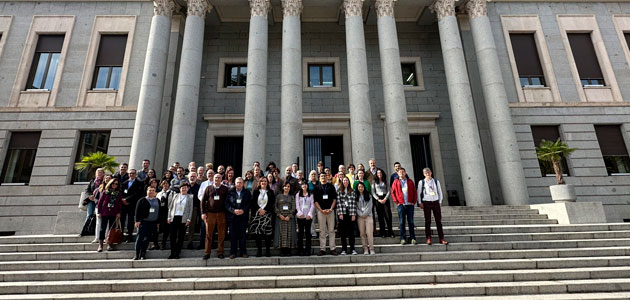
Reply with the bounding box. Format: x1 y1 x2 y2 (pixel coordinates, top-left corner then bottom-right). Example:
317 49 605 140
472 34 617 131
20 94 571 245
0 0 630 233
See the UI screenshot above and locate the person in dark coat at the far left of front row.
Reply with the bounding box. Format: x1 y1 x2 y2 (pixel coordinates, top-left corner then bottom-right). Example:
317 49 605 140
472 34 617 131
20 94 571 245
133 186 160 260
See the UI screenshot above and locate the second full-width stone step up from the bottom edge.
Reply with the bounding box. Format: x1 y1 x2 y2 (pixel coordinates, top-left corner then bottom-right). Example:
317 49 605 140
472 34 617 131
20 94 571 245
0 266 630 295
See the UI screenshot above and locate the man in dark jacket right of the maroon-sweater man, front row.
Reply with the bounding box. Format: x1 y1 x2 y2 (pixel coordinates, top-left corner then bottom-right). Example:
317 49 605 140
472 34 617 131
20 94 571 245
225 177 252 259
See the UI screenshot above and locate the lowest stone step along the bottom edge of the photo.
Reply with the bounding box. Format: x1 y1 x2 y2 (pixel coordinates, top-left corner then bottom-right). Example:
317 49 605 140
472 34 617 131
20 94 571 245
0 278 630 300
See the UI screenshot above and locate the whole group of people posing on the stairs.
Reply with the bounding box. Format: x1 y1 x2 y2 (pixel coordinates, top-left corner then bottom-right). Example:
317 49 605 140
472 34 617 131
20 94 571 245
86 159 448 260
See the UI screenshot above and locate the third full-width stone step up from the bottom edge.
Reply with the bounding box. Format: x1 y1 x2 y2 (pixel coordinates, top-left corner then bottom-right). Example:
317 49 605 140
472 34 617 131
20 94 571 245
0 256 630 282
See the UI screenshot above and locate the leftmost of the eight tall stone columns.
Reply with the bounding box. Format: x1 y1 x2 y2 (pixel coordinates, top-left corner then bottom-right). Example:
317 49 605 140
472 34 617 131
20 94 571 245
129 0 175 168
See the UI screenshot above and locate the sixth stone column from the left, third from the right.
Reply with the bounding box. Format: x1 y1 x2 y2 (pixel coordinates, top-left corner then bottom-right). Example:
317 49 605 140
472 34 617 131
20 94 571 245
374 0 419 180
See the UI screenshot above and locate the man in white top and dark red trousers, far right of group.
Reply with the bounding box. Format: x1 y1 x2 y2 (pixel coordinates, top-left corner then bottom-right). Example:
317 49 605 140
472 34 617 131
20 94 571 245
418 168 448 245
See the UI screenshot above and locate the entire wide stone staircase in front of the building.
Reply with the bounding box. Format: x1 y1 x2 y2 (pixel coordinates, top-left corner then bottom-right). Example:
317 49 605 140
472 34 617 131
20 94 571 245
0 206 630 300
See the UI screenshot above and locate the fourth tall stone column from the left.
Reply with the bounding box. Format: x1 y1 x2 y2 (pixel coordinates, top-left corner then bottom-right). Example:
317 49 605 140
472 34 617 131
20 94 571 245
278 0 304 170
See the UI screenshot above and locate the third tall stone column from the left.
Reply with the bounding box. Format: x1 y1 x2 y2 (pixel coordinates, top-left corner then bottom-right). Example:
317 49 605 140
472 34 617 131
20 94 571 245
242 0 271 172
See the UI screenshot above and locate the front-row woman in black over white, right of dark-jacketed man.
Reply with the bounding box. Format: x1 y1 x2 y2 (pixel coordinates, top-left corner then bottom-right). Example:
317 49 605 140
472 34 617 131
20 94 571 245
249 178 276 257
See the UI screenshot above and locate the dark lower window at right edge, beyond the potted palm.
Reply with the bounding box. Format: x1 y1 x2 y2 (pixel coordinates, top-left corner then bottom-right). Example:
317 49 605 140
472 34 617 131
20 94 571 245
595 125 630 175
